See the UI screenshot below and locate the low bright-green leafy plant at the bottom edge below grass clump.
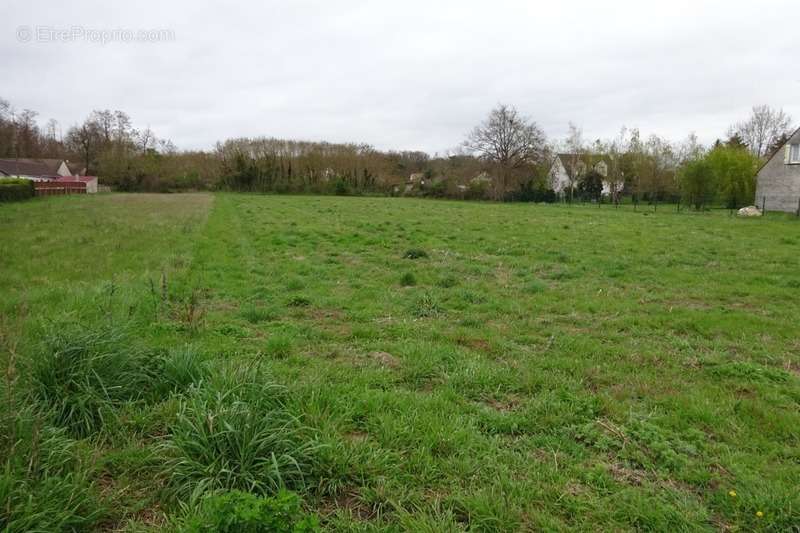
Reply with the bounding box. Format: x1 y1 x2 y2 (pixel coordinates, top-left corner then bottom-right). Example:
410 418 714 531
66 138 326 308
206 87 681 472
181 490 320 533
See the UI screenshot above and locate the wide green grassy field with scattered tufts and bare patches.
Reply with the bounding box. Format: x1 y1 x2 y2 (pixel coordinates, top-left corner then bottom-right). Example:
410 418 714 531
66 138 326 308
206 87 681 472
0 194 800 532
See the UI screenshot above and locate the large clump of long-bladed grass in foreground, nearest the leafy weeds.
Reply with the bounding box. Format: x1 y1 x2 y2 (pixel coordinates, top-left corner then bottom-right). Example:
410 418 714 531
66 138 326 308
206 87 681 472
164 373 318 499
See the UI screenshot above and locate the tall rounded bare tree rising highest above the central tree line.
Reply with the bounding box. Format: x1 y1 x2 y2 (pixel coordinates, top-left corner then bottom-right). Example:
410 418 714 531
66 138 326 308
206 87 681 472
464 104 546 197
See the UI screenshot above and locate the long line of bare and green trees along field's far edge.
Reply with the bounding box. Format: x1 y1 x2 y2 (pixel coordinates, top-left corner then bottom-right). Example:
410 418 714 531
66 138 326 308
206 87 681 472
0 98 792 208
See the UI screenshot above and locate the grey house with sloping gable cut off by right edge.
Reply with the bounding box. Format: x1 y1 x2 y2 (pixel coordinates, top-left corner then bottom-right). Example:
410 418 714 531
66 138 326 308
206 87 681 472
755 129 800 212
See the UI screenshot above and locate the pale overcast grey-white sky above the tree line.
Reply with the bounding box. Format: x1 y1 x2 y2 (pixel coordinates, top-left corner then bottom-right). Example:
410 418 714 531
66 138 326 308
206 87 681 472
0 0 800 153
